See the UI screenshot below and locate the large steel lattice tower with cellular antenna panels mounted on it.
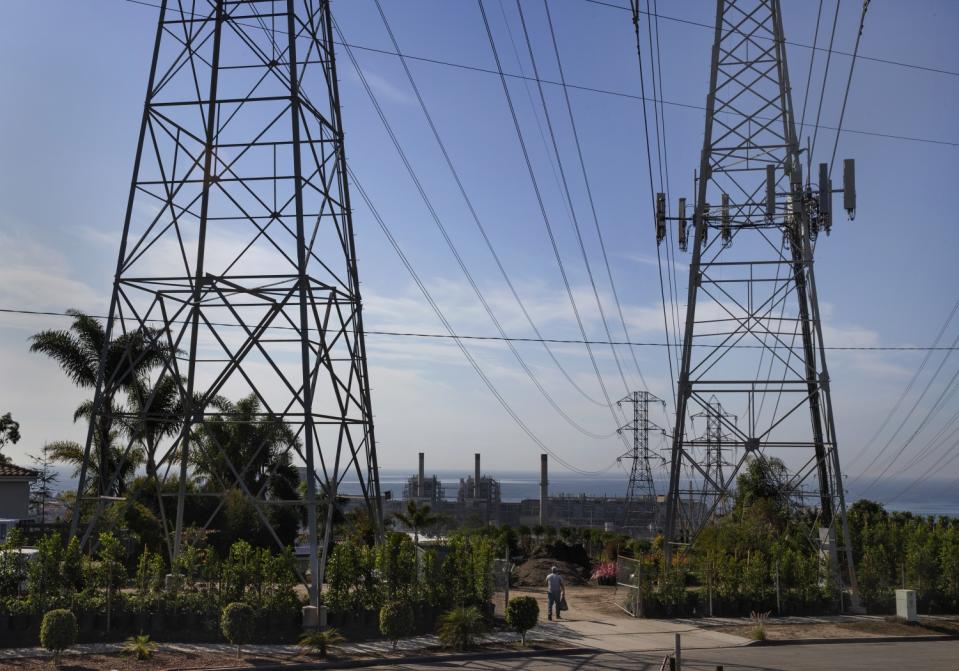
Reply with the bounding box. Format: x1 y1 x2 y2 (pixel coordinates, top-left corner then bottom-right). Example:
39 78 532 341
656 0 857 608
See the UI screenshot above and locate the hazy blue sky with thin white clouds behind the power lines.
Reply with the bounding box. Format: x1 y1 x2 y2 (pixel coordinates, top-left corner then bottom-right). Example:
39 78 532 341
0 0 959 502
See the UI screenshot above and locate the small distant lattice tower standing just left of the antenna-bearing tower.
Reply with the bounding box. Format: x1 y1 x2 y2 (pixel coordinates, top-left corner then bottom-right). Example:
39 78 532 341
616 391 663 531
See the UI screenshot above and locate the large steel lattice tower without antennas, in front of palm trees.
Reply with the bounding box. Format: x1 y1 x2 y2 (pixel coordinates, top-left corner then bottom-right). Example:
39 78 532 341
73 0 382 606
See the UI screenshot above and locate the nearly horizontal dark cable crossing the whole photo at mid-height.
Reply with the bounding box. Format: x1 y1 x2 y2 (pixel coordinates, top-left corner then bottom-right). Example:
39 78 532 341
0 308 959 352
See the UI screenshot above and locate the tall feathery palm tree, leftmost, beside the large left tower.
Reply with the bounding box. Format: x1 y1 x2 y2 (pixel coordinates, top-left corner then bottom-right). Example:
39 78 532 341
30 310 169 494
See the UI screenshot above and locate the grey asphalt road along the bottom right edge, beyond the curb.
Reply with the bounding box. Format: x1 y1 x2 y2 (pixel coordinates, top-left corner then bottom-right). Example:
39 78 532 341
356 641 959 671
